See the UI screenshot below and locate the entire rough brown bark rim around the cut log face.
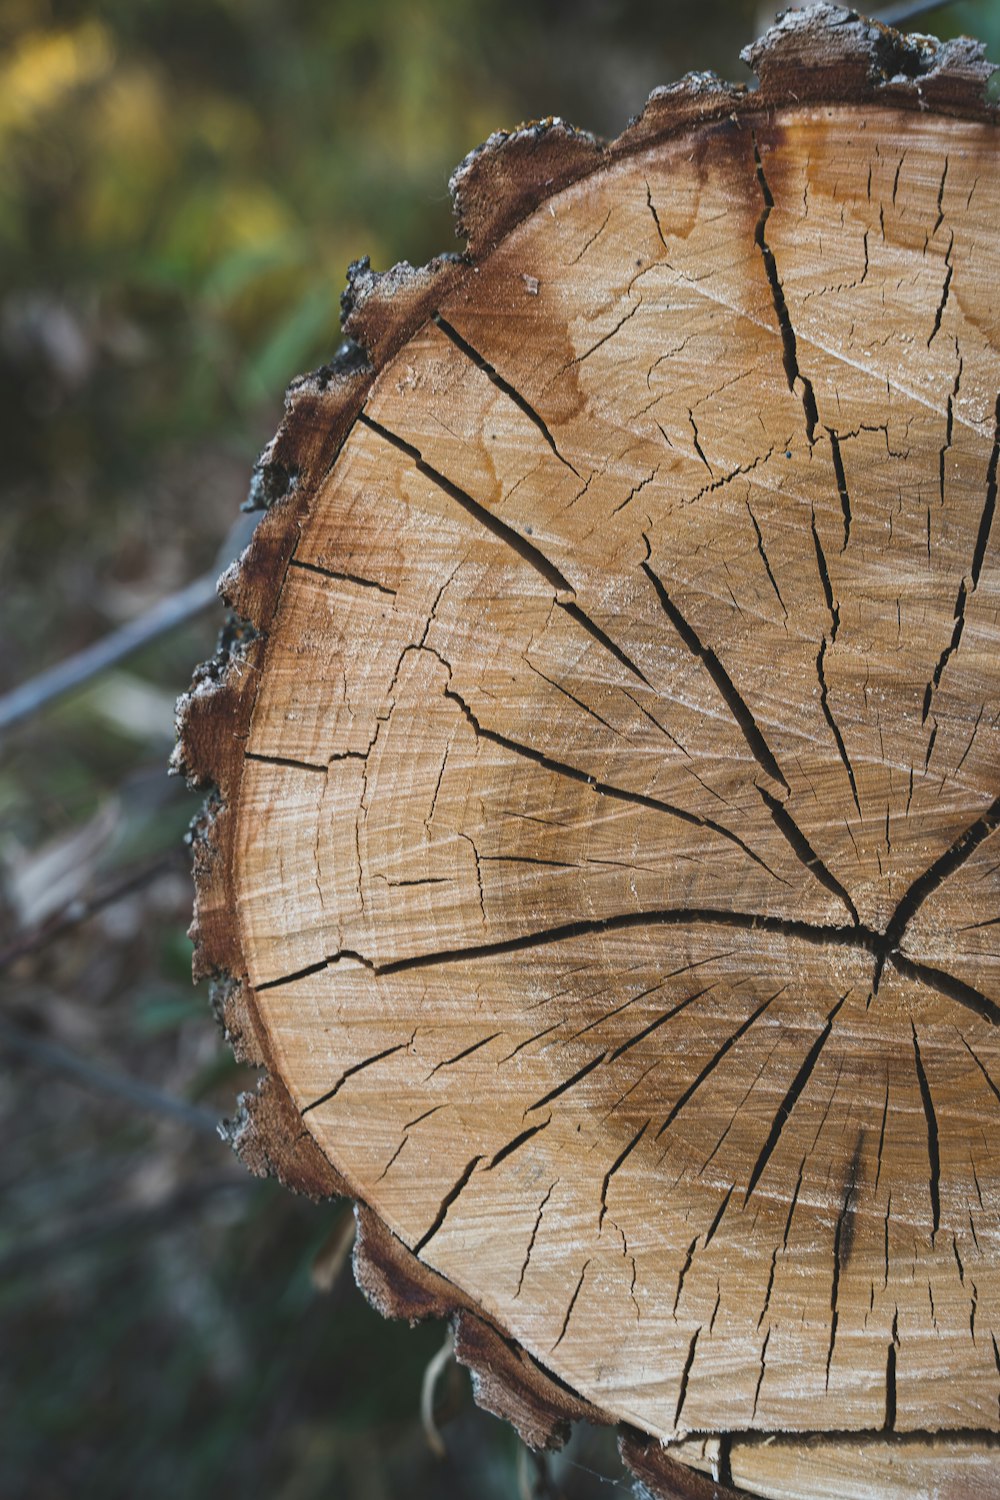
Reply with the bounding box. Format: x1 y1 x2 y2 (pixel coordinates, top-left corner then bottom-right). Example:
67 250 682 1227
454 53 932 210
172 5 999 1500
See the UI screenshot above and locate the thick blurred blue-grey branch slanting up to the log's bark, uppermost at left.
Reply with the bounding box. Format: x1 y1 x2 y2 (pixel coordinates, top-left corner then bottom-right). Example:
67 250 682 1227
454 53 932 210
0 513 259 734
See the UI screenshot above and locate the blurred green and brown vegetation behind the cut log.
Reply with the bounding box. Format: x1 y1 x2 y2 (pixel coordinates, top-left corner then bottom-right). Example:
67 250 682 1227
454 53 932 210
0 0 1000 1500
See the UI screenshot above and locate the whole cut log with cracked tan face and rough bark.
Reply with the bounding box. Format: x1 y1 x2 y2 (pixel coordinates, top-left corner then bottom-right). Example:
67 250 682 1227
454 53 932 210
180 8 1000 1496
